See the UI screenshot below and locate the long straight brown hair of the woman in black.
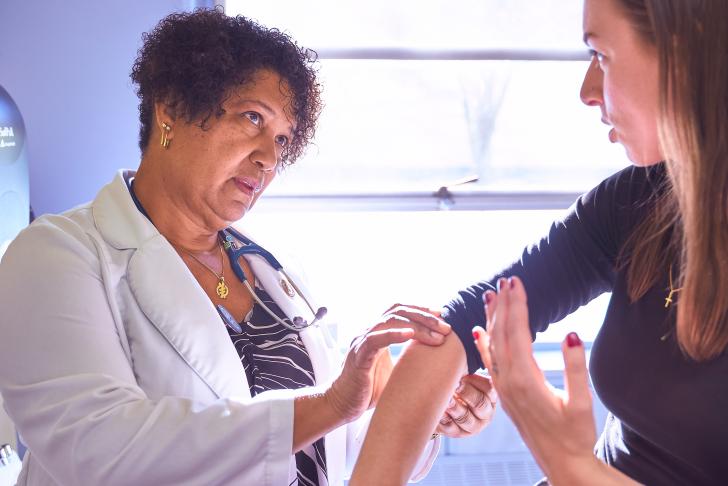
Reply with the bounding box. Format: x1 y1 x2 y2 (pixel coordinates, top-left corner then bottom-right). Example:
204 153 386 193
619 0 728 361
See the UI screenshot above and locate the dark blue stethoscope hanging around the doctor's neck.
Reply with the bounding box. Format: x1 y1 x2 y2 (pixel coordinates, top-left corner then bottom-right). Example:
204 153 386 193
127 179 328 334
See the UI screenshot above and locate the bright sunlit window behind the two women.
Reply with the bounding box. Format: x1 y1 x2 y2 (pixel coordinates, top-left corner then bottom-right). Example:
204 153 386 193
226 0 627 345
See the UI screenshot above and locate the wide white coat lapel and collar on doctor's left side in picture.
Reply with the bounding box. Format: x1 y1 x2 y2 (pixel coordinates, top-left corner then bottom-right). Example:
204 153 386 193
92 171 250 398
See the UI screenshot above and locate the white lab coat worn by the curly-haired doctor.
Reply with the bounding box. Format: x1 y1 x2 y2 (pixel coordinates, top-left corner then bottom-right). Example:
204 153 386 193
0 171 438 486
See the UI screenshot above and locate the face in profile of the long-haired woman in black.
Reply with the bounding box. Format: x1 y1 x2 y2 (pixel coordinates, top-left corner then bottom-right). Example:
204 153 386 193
581 0 663 166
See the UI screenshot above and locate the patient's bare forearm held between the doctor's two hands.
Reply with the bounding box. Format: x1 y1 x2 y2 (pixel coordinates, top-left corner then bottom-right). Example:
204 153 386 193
349 334 466 486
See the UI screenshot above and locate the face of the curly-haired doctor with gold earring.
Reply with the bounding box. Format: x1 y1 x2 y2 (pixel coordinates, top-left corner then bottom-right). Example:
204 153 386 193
164 70 293 228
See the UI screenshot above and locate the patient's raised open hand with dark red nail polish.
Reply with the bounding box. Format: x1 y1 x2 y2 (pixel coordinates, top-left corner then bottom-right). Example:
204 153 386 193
473 277 616 484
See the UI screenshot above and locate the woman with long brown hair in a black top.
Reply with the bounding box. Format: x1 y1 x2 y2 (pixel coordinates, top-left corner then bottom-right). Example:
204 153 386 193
350 0 728 486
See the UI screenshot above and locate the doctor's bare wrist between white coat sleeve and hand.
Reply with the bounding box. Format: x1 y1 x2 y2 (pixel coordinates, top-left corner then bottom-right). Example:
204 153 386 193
293 392 347 453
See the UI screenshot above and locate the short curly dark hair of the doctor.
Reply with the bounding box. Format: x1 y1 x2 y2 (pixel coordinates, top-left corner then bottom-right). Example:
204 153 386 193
131 8 322 165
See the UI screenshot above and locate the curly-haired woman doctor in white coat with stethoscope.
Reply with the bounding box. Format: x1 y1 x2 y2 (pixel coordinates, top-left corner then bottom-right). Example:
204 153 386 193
0 10 492 486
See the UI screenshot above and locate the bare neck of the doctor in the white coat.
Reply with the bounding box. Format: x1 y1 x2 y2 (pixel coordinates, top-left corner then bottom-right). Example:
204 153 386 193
134 158 222 253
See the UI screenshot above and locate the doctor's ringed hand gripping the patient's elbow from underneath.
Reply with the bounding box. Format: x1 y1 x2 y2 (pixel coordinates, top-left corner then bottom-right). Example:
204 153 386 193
435 373 498 438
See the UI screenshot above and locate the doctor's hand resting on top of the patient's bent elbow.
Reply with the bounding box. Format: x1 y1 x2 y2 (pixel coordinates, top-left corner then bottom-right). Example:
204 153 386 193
326 304 451 421
